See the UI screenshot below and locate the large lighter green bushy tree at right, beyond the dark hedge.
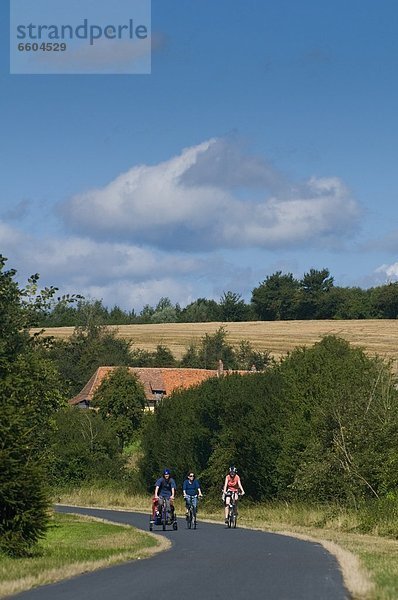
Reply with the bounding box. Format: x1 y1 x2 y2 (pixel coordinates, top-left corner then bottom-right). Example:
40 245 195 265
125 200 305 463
278 336 398 502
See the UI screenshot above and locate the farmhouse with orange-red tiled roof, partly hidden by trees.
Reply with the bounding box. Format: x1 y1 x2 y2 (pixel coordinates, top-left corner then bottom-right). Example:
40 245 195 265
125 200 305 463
69 361 227 410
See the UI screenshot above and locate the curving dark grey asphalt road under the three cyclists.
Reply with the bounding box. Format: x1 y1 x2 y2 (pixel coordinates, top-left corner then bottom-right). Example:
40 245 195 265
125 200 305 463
14 506 350 600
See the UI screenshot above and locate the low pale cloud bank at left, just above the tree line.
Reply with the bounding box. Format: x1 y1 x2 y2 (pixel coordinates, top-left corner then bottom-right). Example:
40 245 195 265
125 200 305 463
0 221 213 309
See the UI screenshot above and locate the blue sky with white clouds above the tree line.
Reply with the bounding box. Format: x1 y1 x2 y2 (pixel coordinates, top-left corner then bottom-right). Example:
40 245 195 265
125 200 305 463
0 0 398 310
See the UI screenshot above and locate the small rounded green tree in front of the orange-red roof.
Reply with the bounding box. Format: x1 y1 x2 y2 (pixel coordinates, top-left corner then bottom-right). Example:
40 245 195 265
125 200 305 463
91 367 146 447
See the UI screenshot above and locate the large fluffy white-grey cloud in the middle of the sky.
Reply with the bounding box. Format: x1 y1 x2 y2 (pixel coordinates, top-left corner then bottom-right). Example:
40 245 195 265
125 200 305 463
61 139 361 251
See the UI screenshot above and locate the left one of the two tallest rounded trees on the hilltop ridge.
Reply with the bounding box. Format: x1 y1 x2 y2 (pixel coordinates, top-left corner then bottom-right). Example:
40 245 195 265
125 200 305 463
252 271 300 321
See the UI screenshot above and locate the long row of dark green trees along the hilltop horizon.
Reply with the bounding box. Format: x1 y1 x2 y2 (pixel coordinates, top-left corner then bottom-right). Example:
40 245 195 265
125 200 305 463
39 269 398 327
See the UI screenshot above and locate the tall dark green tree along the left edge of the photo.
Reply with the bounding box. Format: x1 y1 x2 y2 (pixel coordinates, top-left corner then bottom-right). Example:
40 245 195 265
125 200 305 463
0 256 63 555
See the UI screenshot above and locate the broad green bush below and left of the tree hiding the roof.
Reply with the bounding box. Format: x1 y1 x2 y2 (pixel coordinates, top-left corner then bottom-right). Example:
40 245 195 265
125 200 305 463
51 407 125 486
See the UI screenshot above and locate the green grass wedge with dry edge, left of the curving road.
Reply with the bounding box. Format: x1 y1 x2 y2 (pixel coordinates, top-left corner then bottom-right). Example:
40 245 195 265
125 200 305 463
0 514 163 598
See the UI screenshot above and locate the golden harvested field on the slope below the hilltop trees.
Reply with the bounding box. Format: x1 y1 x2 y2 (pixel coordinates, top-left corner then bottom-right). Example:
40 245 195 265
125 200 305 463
31 319 398 366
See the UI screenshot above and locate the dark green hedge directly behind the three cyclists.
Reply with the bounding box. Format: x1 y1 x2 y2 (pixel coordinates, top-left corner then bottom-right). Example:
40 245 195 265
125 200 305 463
142 373 280 498
